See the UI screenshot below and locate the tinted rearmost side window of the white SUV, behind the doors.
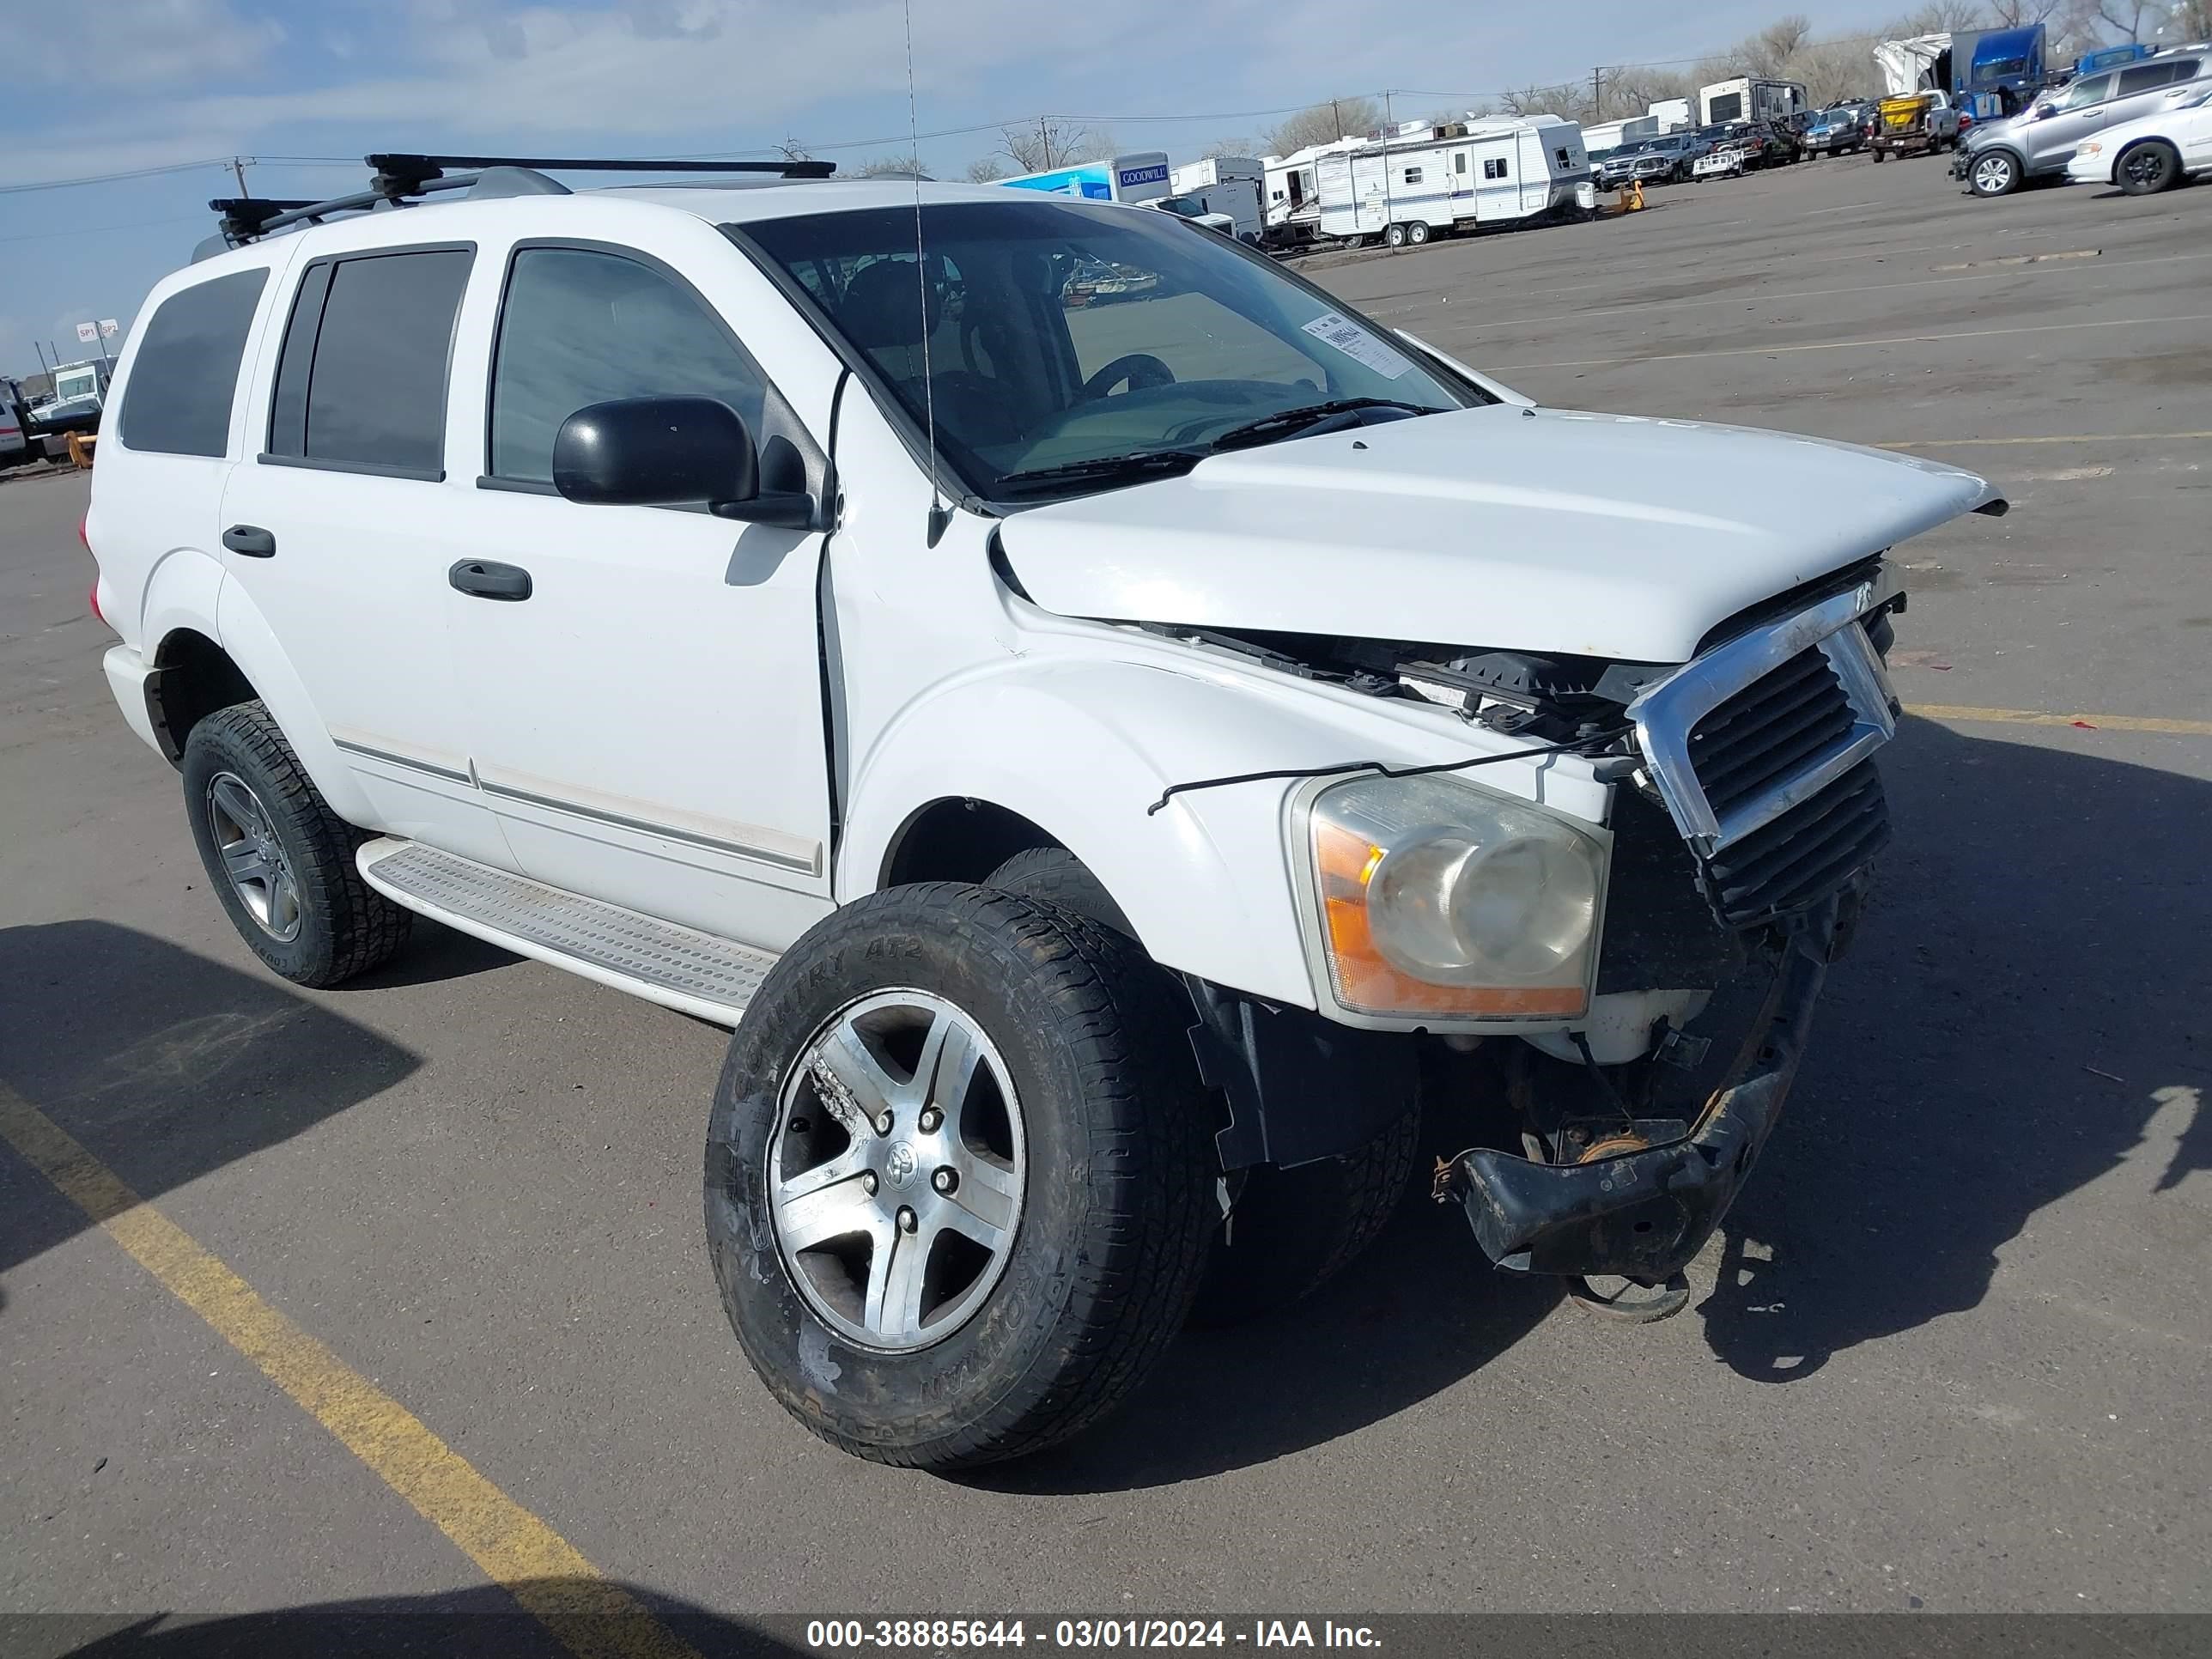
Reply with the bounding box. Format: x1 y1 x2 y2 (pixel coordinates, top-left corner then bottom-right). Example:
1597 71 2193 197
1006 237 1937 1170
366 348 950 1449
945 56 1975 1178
118 270 268 456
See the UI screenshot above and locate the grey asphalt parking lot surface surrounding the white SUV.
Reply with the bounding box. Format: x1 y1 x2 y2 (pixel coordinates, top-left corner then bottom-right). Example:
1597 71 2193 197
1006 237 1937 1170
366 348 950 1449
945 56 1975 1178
0 149 2212 1646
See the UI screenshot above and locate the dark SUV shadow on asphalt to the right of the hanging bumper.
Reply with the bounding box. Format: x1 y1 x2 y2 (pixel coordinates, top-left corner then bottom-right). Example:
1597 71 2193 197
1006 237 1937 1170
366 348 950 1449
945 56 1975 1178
1697 719 2212 1382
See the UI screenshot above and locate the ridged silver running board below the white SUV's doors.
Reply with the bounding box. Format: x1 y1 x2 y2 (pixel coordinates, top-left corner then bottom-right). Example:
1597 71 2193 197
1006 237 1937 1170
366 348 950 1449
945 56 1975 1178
354 836 776 1026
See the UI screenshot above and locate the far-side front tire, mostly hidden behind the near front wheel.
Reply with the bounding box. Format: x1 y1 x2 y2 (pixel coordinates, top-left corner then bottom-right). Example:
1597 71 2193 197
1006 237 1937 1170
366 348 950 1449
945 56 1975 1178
988 848 1420 1328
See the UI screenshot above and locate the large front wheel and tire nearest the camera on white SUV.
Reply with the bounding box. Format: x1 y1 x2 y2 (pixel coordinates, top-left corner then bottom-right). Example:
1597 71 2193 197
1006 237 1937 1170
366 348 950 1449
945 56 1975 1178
706 883 1214 1468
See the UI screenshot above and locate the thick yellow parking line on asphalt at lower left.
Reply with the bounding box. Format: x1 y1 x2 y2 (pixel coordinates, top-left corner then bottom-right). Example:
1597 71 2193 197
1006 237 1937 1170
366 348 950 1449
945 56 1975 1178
0 1084 696 1659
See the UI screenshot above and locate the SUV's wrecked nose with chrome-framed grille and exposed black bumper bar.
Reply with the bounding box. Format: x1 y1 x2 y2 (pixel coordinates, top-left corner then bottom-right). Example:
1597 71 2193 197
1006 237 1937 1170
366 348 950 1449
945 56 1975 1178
1436 568 1902 1285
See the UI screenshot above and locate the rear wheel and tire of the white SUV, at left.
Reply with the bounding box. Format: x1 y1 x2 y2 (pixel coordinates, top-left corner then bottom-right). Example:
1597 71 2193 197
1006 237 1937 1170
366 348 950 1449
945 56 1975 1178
184 703 414 988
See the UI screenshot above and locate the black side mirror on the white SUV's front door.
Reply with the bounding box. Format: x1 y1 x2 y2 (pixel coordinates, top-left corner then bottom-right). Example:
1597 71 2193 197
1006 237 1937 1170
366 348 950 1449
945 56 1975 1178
553 398 814 529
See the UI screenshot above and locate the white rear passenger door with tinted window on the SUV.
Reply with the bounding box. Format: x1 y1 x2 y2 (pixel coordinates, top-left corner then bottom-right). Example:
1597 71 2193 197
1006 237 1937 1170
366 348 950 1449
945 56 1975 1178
222 246 514 867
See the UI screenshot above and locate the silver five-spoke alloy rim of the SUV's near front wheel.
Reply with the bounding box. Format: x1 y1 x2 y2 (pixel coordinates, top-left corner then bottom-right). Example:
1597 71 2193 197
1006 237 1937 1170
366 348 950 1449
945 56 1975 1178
768 988 1026 1352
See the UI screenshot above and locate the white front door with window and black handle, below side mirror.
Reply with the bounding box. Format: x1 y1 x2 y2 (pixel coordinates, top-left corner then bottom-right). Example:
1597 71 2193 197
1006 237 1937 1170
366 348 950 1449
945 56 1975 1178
445 243 830 949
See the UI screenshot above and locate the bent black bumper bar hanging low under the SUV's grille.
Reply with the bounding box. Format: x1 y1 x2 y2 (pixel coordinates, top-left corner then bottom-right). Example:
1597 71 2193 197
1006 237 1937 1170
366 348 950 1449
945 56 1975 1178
1443 900 1836 1283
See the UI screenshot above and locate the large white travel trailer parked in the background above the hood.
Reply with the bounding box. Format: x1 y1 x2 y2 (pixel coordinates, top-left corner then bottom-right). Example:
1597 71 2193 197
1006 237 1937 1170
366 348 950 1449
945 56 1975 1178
1316 115 1593 248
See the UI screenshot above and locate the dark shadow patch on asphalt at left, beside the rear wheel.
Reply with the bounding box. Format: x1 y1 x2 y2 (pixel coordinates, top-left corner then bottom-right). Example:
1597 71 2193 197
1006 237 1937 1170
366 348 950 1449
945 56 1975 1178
0 921 417 1270
